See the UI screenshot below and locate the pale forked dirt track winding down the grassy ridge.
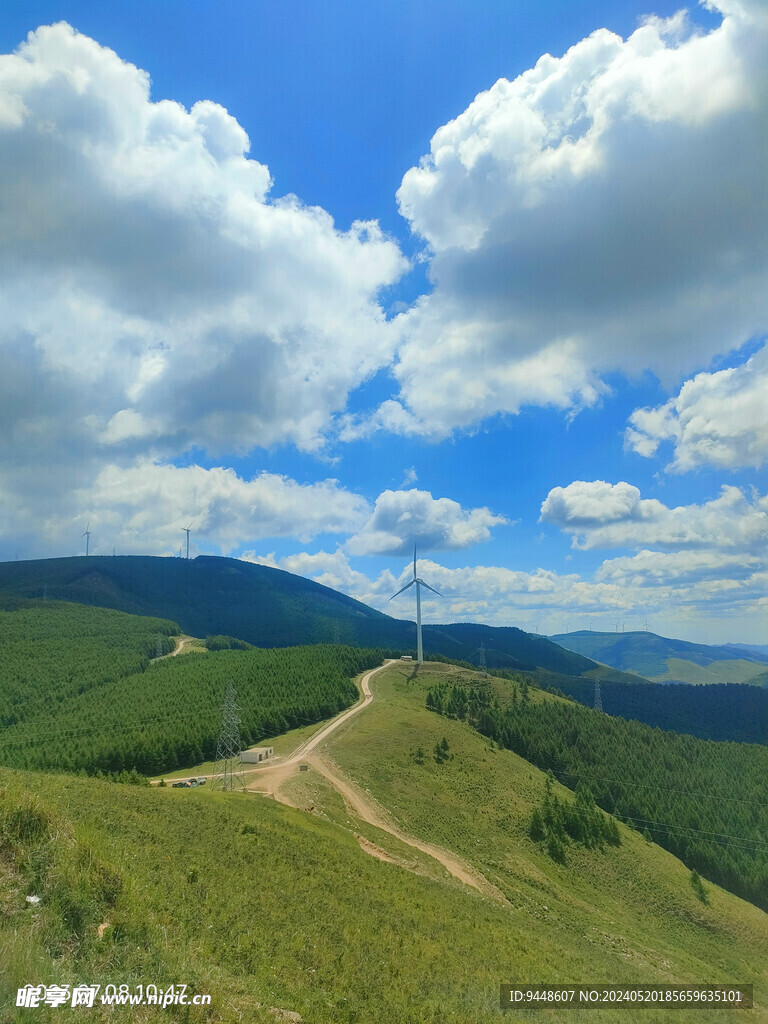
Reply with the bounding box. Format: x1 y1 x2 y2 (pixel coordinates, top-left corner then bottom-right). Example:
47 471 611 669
247 662 508 903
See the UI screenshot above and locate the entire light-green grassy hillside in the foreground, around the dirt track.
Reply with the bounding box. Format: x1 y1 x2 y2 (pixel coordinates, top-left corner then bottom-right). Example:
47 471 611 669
0 665 768 1024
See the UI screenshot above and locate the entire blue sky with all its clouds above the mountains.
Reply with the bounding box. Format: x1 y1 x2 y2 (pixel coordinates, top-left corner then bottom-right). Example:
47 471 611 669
0 0 768 642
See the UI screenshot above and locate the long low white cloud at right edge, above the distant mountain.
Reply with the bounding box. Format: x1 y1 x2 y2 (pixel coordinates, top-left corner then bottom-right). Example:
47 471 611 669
541 480 768 552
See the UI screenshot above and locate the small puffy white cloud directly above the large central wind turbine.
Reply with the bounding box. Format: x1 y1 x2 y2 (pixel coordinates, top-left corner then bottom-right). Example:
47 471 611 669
347 488 508 555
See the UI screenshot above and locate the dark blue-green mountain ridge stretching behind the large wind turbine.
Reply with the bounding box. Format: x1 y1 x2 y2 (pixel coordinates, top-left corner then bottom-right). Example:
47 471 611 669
0 555 638 681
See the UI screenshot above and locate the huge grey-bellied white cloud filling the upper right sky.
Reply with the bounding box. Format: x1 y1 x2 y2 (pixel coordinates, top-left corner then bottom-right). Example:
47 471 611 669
358 0 768 437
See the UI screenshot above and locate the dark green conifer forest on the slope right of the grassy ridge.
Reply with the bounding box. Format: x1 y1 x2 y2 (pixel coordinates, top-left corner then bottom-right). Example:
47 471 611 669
427 683 768 909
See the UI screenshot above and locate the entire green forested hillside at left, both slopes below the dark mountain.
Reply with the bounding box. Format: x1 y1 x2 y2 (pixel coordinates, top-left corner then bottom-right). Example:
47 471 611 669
0 601 384 774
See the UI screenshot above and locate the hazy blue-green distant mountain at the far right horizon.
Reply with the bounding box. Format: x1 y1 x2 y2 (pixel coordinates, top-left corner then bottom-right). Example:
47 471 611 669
550 630 768 686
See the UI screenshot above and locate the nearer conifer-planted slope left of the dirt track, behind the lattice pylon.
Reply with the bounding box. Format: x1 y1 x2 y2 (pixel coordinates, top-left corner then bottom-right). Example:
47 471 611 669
0 645 387 775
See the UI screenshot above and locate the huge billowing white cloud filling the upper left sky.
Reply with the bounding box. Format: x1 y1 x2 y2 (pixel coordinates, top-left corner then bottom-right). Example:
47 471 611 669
0 24 406 471
